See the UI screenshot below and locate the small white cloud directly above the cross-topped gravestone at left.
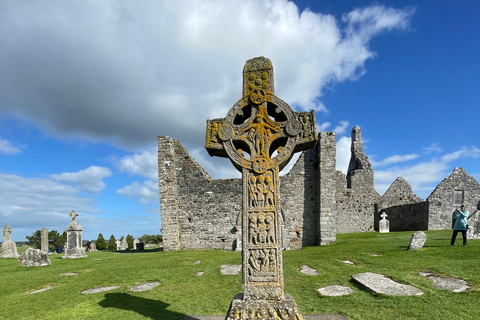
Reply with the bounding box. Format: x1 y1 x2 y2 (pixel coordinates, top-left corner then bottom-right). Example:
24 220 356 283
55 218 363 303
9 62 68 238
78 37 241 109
51 166 112 193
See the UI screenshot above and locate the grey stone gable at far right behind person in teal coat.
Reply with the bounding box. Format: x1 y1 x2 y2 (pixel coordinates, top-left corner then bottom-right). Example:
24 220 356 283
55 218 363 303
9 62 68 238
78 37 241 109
427 168 480 239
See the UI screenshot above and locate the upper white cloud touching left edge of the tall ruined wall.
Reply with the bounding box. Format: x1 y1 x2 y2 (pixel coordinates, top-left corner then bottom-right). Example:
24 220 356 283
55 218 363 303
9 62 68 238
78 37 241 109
114 147 158 180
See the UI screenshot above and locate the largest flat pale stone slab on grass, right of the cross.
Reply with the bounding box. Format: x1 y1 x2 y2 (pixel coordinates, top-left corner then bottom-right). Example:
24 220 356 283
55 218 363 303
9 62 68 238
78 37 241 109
352 272 423 296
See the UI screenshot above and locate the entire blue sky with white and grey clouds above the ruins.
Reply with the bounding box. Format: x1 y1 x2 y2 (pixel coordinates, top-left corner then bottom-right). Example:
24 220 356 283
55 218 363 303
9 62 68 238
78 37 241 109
0 0 480 241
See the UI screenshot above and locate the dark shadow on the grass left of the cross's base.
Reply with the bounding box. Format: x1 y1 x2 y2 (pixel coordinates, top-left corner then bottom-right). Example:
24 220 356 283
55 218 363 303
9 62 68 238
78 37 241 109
99 293 184 320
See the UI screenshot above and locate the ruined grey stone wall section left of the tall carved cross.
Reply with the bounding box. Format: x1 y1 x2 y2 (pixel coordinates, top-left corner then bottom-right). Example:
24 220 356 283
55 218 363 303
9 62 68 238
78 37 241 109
158 136 242 251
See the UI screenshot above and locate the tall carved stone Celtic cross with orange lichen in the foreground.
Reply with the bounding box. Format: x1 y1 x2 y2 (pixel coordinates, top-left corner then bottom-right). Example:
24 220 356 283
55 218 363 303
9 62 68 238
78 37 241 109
205 57 317 320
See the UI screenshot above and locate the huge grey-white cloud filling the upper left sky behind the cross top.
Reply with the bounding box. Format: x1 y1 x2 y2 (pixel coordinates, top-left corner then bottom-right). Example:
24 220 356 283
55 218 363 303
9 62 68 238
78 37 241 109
0 0 413 157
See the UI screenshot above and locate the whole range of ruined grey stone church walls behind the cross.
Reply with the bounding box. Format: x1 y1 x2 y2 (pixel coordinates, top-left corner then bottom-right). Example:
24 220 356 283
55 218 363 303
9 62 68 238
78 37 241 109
158 127 480 251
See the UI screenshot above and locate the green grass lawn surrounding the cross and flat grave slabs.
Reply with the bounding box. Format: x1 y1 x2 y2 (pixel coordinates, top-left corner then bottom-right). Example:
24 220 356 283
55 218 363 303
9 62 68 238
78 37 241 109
0 230 480 320
